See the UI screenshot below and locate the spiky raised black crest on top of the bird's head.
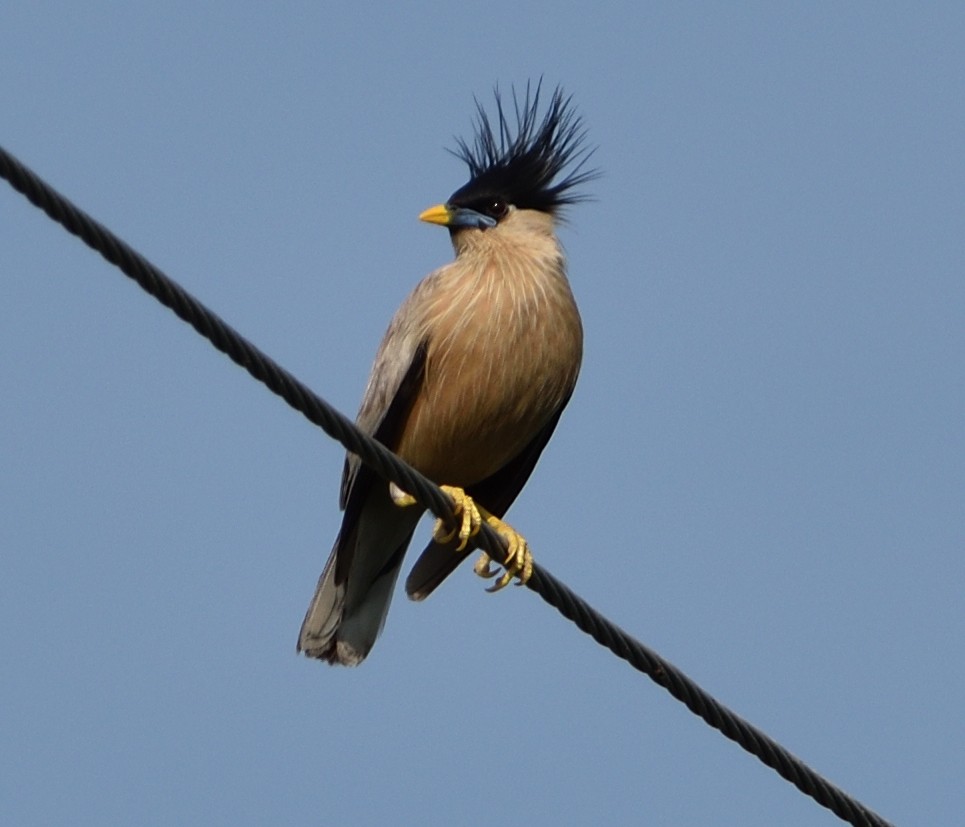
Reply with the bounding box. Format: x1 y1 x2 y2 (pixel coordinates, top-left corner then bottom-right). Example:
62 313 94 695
449 81 599 213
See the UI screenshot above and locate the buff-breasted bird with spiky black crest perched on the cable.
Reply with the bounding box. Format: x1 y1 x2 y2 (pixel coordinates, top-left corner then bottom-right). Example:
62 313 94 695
297 80 599 666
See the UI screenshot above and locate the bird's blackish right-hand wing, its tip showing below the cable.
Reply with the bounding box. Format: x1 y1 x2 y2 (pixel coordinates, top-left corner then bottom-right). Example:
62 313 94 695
405 397 569 600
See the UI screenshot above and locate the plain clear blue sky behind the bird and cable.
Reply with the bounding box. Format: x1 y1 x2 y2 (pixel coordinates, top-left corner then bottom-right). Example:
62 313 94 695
0 2 965 826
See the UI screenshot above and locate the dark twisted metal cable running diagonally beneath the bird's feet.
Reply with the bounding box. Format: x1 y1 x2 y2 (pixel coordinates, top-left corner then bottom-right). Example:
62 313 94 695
0 147 890 827
